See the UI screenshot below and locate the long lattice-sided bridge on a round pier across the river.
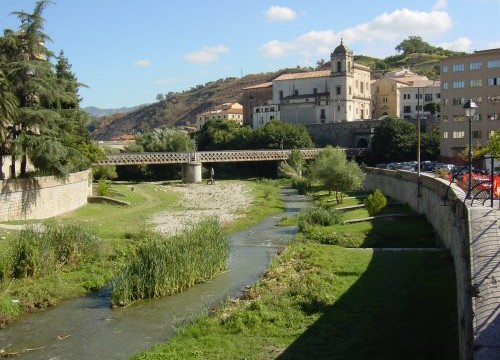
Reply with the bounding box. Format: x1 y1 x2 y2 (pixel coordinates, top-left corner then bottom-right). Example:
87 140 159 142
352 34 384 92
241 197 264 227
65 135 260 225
96 148 366 183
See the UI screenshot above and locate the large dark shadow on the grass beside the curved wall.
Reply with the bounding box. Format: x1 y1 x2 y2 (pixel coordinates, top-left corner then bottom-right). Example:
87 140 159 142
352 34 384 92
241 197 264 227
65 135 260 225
278 250 458 360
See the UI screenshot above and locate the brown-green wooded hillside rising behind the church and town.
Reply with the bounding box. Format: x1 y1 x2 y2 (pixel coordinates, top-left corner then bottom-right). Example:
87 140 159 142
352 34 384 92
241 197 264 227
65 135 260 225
90 36 459 140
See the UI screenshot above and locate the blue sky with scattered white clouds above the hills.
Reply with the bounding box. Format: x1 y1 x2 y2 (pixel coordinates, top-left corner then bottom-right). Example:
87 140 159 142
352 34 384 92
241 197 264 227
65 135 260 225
0 0 500 108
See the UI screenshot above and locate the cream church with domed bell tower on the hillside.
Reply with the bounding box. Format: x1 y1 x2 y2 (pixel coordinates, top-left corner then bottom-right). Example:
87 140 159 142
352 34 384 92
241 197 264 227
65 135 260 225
248 41 371 128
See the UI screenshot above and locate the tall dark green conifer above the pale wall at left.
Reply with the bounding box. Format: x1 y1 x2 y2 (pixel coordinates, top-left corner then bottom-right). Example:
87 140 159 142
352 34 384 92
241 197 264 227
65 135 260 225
0 1 101 177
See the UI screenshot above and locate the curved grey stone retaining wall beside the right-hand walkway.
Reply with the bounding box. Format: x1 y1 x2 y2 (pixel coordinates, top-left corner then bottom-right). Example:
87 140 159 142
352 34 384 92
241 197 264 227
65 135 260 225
365 168 473 360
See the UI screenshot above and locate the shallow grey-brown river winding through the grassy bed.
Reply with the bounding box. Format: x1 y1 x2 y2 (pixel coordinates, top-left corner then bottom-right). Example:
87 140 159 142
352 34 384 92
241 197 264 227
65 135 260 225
0 189 310 360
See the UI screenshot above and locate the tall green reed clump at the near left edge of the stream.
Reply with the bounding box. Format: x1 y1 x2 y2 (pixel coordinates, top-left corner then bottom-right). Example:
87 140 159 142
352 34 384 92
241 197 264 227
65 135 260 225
111 219 229 306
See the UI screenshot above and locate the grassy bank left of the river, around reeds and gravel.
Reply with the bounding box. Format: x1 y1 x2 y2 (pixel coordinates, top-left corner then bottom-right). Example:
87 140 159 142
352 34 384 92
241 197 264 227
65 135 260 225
0 181 283 324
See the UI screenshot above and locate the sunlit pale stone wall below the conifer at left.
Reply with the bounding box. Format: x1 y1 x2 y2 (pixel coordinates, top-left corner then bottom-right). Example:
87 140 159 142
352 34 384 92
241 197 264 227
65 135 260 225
0 170 92 221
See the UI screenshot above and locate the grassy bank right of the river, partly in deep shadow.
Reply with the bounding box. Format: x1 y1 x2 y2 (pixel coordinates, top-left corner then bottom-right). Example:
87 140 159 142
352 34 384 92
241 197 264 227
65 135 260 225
134 190 458 360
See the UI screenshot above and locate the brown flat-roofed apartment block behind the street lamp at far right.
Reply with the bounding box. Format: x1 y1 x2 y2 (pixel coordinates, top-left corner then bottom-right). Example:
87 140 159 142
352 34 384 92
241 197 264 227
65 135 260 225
440 49 500 157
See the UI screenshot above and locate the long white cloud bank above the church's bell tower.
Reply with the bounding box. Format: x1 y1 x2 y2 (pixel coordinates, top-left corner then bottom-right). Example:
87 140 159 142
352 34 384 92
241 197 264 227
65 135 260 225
259 9 452 57
